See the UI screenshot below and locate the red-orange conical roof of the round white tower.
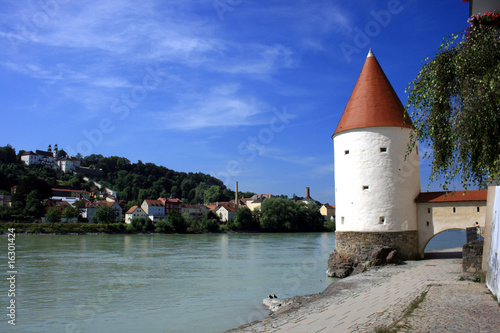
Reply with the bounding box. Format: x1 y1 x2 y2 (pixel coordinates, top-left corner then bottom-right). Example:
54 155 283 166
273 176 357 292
332 50 412 137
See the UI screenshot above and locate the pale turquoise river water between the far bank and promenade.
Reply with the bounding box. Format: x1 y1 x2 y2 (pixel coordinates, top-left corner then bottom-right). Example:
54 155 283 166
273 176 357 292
0 233 465 333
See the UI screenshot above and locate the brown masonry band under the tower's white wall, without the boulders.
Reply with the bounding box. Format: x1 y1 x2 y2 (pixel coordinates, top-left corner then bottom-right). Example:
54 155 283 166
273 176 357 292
335 231 420 260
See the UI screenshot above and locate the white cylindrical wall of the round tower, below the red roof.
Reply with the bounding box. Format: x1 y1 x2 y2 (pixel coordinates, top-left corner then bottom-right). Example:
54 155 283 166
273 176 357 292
333 127 420 232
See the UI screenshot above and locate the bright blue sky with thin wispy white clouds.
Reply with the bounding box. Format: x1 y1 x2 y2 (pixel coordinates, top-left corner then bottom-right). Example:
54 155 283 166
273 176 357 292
0 0 469 203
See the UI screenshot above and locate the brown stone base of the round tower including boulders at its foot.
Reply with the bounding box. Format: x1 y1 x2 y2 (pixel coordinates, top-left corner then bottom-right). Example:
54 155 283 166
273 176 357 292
327 230 420 278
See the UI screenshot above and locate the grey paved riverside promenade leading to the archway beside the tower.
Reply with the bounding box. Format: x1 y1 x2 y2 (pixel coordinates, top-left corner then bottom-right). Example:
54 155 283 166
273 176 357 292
228 249 500 333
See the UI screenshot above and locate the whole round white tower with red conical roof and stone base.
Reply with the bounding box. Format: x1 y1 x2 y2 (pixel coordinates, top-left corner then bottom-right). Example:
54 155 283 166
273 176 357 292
332 50 420 262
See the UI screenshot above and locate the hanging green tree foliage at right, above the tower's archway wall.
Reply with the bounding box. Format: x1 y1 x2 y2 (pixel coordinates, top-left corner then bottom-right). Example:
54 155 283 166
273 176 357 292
406 13 500 189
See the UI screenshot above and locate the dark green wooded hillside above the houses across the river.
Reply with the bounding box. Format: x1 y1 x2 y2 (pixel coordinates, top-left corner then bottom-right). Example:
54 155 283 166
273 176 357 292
0 145 254 206
